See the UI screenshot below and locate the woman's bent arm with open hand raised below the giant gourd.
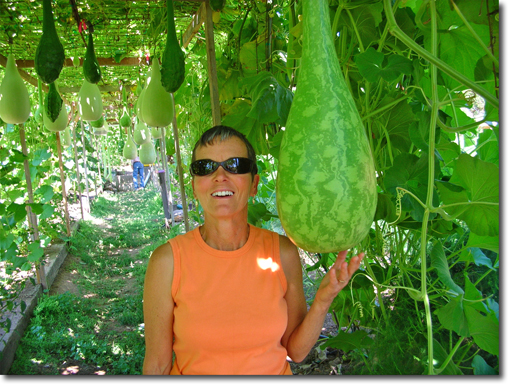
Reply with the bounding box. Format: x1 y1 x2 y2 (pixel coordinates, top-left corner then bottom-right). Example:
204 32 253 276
280 236 364 362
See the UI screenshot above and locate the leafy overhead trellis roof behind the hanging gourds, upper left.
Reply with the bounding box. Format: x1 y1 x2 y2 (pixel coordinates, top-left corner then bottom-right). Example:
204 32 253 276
0 0 236 116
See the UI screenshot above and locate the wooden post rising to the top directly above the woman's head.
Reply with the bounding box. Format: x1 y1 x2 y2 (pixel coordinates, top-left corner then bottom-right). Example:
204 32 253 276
201 1 221 126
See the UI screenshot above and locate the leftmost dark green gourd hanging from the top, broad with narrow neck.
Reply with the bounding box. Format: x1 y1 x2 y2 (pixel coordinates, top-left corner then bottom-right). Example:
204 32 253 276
34 0 65 84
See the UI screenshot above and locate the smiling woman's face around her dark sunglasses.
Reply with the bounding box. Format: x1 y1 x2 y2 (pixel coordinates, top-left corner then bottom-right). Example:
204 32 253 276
192 137 259 218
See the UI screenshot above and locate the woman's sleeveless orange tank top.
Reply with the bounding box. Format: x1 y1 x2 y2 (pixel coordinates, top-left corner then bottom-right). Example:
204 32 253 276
169 225 292 375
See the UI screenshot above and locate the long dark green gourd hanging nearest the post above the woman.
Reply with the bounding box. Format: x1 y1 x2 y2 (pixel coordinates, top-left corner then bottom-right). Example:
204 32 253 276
160 0 185 93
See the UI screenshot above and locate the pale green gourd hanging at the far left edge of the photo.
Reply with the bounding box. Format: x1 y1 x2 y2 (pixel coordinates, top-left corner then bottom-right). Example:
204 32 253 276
0 54 30 125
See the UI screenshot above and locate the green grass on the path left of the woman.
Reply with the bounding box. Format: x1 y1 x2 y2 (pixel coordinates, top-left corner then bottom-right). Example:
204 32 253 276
9 189 176 375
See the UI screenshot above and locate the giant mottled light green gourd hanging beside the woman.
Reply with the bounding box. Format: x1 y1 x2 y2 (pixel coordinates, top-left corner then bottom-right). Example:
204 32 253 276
276 0 377 253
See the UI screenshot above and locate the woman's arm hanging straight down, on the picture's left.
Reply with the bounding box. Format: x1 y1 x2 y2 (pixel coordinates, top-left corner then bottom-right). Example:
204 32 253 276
143 243 174 375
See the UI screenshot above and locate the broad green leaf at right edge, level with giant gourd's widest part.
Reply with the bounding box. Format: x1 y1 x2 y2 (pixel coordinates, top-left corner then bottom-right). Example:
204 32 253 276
437 154 499 236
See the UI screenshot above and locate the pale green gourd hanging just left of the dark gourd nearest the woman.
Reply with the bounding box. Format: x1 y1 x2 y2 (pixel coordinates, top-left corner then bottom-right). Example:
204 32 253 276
141 58 174 127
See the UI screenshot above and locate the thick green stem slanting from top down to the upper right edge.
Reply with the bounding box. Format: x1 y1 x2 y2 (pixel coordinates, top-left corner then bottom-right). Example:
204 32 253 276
383 0 499 109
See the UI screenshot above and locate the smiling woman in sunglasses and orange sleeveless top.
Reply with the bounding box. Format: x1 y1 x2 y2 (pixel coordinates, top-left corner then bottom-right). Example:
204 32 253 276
143 126 363 375
